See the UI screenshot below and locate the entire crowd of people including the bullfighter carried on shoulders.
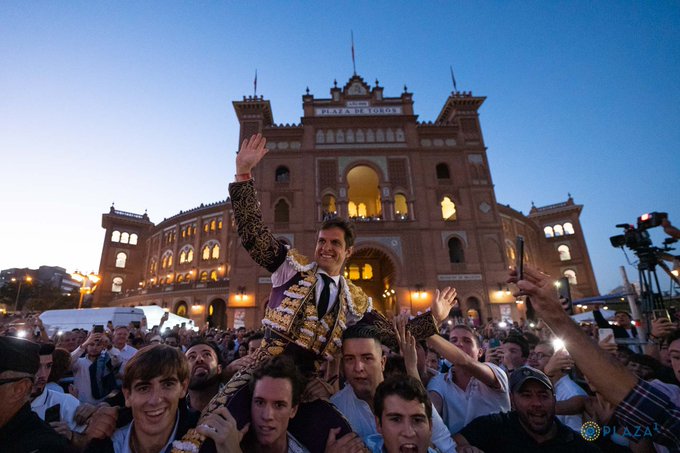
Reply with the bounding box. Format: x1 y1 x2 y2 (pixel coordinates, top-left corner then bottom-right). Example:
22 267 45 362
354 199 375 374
0 135 680 453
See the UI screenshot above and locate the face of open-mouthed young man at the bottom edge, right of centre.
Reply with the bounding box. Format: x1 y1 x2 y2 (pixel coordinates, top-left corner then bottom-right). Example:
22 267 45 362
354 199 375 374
376 395 432 453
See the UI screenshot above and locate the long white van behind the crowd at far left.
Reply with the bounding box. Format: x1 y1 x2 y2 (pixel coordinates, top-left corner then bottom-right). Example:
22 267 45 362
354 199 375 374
39 307 144 336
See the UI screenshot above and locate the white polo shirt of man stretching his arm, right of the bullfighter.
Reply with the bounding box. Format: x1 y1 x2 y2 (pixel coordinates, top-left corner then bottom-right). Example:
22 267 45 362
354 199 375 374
427 362 510 434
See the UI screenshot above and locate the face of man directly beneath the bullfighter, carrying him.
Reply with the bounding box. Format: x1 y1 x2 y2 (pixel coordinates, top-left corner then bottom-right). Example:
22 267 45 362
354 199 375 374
342 338 385 401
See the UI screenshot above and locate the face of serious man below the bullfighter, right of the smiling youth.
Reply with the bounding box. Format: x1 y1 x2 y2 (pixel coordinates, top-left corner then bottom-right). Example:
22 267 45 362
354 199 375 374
250 376 297 447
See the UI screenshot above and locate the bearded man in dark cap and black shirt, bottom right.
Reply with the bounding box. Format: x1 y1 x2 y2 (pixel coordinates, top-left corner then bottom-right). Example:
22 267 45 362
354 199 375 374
454 366 600 453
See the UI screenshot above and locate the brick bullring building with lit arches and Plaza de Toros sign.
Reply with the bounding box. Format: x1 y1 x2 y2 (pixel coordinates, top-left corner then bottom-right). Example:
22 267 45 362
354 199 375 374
94 75 598 327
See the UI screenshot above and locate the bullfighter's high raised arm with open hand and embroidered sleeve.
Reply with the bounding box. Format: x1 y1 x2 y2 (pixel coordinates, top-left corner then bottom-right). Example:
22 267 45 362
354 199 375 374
229 134 287 272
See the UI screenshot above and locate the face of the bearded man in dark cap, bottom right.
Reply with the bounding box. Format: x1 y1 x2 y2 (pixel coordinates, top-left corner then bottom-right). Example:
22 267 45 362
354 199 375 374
512 379 555 435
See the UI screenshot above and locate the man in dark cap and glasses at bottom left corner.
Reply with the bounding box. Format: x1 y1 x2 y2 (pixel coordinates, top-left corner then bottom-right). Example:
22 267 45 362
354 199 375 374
0 337 70 453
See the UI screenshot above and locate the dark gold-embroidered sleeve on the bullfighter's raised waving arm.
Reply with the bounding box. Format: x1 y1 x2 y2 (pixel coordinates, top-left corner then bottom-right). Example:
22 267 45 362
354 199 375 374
229 179 287 272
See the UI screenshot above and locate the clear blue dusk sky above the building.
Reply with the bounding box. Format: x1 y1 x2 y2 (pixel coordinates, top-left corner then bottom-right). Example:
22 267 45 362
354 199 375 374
0 0 680 293
